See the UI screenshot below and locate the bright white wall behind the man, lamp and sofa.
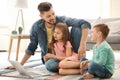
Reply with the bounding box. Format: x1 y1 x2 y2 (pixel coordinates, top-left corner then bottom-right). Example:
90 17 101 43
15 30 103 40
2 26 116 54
0 0 120 50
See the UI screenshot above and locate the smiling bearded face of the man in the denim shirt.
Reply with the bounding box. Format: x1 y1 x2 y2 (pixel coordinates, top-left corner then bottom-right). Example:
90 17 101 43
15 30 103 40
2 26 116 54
40 8 56 25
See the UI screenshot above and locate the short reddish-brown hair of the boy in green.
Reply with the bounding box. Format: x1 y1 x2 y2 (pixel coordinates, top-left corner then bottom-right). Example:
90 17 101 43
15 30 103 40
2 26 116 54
94 24 110 39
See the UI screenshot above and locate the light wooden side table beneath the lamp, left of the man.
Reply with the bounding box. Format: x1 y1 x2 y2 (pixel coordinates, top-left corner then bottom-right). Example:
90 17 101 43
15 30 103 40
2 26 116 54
8 34 30 61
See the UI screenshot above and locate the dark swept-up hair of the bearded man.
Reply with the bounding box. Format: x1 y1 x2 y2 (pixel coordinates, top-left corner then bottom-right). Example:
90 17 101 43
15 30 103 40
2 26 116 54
38 2 52 13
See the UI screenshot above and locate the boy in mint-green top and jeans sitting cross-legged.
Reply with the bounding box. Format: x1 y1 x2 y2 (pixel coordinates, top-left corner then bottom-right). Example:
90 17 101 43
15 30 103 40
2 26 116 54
80 24 115 79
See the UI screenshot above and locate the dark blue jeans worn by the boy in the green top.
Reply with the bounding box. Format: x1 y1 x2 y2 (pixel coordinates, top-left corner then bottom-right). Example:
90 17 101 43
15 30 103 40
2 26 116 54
80 58 112 78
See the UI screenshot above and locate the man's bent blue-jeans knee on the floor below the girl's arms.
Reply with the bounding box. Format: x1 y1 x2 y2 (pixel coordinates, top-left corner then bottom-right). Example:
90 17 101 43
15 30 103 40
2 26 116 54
45 58 60 72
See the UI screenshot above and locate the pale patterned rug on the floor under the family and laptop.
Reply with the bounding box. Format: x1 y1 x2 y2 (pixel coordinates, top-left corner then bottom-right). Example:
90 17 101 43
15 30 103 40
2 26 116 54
1 65 120 80
